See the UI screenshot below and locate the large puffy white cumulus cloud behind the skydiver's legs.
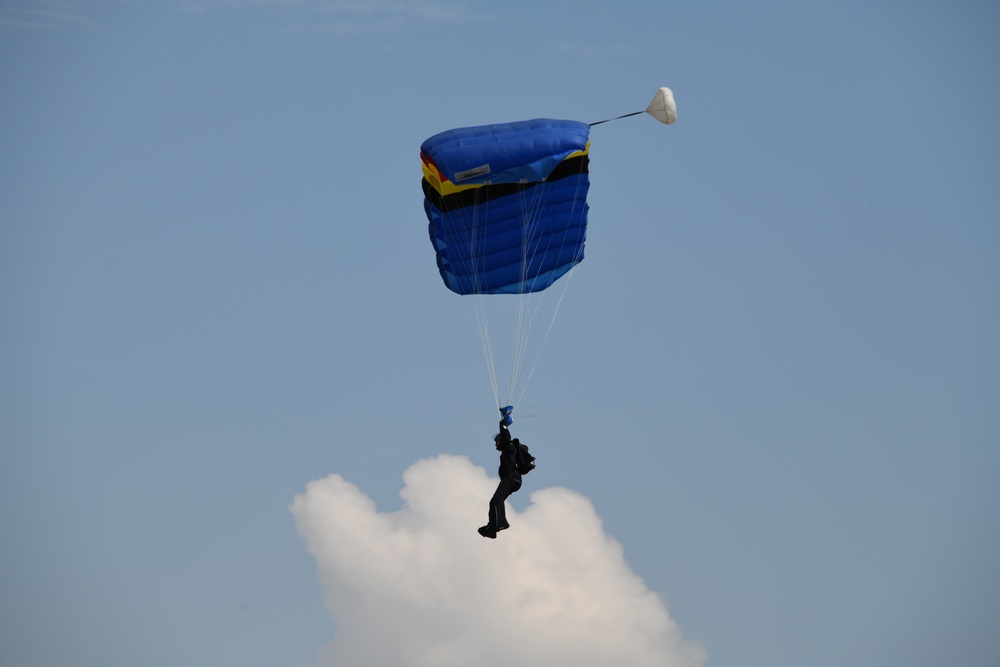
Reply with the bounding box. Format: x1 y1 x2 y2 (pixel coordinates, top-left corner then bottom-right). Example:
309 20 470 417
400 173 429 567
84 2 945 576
291 455 706 667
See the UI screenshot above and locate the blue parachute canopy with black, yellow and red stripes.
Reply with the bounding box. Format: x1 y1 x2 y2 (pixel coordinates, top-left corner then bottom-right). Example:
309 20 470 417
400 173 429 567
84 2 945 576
420 119 590 294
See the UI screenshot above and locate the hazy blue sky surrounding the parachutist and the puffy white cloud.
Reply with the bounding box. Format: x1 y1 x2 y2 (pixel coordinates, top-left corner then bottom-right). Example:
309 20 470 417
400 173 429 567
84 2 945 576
0 0 1000 667
